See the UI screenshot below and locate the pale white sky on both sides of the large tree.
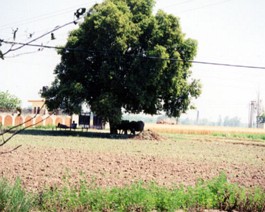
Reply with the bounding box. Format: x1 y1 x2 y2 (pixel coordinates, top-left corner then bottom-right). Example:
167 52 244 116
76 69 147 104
0 0 265 123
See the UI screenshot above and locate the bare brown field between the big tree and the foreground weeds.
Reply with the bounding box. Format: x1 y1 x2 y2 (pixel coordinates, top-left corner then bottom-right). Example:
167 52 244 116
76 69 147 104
0 131 265 191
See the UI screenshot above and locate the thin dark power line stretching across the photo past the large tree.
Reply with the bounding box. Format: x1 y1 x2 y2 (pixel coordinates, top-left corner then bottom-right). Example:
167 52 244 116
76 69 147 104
0 39 265 70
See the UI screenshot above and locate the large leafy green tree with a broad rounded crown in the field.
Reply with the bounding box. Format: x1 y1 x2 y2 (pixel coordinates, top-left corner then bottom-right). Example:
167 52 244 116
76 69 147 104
42 0 200 133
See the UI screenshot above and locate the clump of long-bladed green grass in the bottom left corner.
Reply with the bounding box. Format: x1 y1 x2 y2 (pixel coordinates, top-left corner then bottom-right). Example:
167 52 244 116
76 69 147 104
0 179 33 212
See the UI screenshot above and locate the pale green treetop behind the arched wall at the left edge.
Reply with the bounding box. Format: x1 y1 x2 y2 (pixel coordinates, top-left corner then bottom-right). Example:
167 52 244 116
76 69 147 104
0 91 21 112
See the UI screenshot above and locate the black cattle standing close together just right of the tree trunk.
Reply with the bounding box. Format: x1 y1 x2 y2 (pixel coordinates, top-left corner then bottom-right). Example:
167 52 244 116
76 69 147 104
117 120 144 135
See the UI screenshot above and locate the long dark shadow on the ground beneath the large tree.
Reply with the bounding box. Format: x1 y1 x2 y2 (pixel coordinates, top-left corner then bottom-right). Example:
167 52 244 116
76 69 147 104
19 129 134 139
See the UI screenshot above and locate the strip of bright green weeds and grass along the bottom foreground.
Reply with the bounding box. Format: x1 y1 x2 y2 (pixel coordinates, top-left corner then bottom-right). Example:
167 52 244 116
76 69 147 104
0 173 265 211
